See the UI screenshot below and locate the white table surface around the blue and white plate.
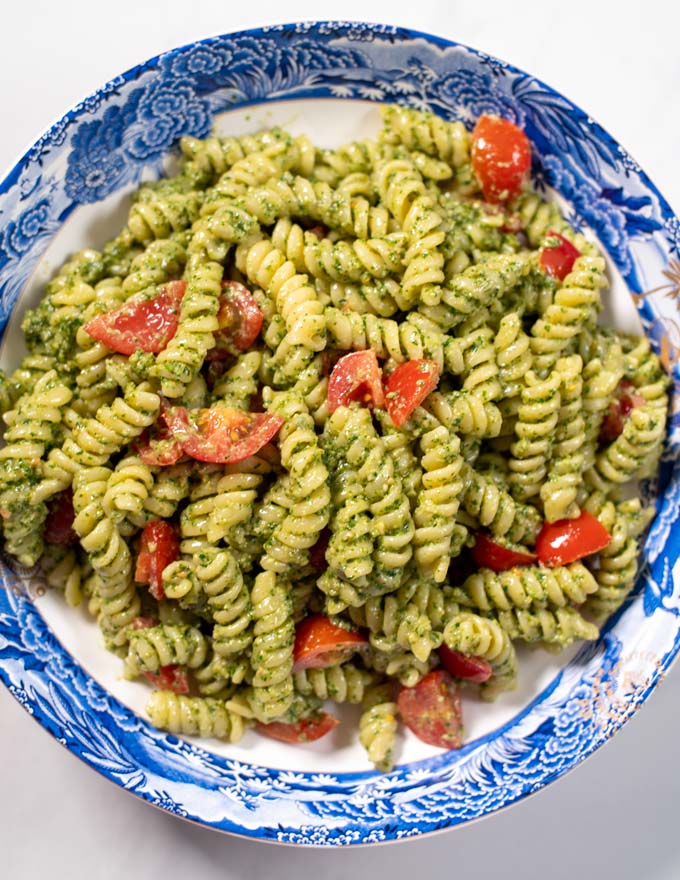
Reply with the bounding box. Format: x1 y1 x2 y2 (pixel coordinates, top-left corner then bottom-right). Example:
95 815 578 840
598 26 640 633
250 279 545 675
0 0 680 880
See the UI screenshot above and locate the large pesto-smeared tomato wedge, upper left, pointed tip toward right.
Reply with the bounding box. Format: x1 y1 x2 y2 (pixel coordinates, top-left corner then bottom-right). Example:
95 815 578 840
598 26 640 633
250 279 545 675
83 281 187 355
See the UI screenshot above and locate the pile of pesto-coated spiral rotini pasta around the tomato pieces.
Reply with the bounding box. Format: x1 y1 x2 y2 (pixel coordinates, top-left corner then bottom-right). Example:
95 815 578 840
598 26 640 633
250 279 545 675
0 106 667 770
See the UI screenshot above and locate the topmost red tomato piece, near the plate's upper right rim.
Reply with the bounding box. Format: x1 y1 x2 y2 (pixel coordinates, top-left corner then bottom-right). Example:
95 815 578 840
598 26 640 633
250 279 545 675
472 115 531 203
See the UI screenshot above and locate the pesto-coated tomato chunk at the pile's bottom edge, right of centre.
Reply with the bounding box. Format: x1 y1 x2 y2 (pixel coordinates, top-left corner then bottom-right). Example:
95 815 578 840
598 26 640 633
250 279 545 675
397 669 463 749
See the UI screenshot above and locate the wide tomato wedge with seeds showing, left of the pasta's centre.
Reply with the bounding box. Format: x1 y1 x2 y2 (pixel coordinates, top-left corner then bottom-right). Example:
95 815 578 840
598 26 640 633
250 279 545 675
163 406 283 464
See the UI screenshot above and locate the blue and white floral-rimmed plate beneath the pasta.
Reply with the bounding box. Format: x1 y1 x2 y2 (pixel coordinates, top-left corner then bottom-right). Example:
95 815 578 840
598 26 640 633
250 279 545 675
0 23 680 845
